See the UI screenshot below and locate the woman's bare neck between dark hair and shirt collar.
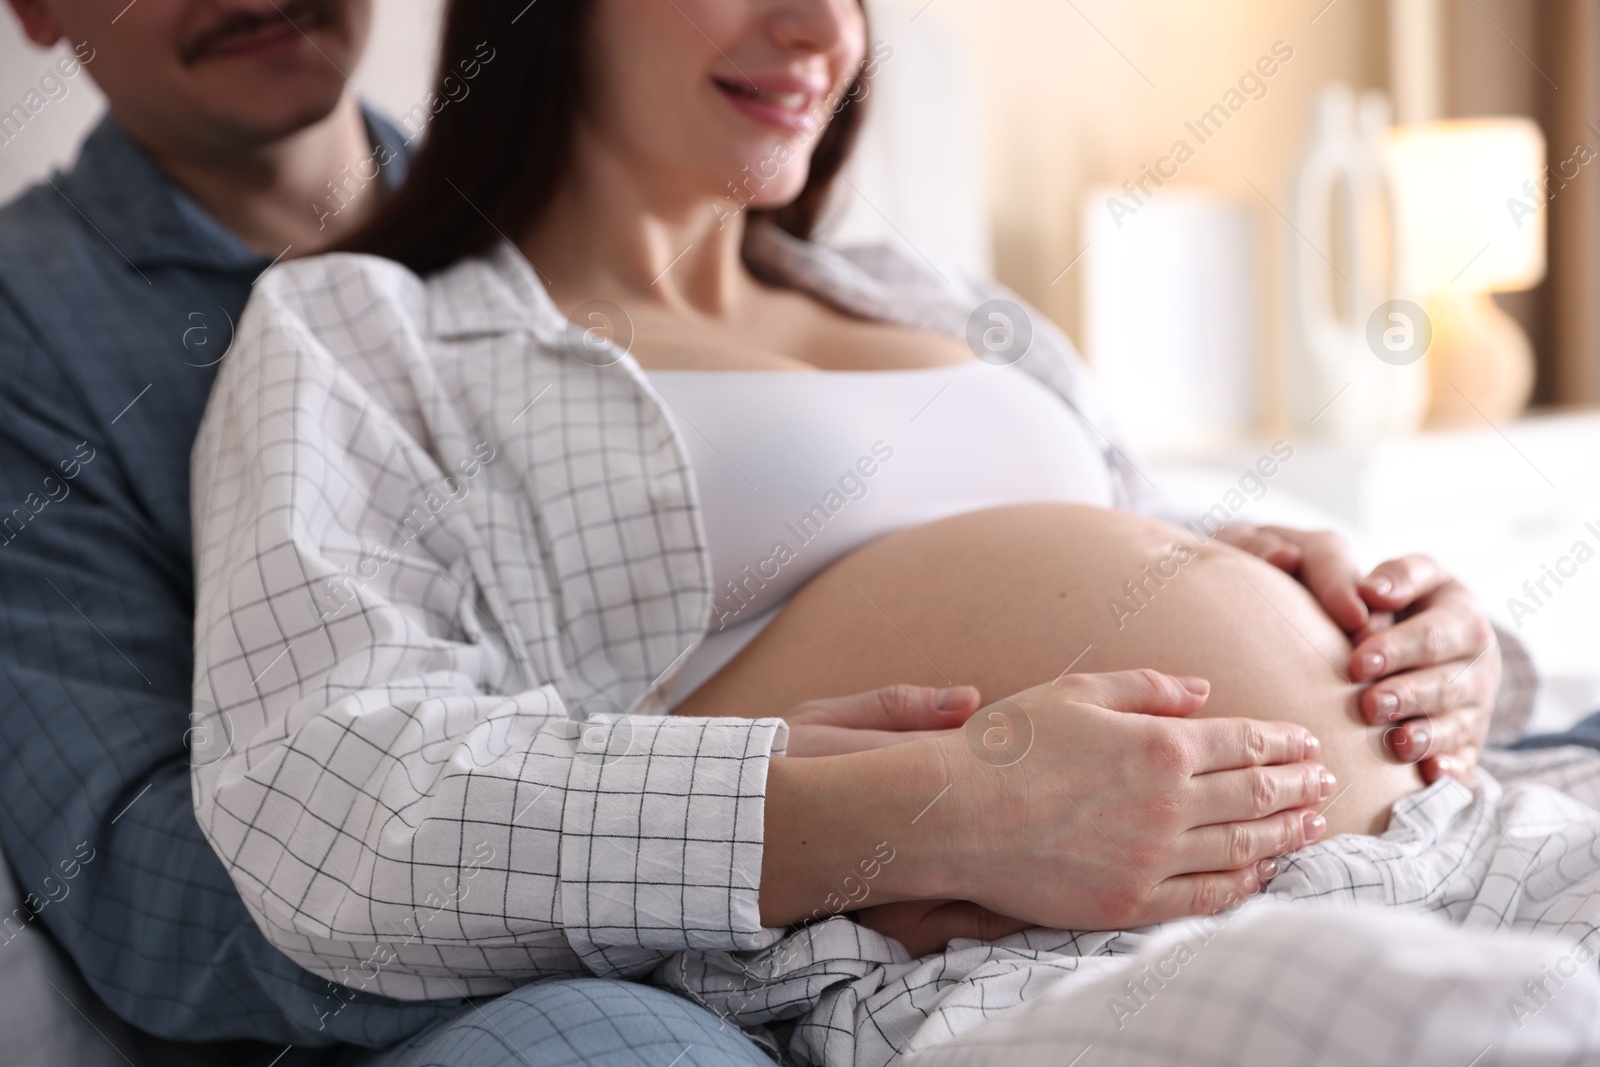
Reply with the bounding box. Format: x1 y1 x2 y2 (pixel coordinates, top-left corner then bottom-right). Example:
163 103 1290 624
520 136 754 318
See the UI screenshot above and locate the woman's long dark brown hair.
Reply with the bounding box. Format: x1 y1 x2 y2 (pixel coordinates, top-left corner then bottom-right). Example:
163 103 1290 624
341 0 867 274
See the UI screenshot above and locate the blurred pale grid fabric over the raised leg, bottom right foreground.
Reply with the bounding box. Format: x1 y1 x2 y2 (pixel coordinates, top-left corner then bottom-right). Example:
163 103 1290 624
899 904 1600 1067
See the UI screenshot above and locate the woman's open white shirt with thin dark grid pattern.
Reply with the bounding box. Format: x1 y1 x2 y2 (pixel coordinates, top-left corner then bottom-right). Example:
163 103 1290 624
194 220 1142 998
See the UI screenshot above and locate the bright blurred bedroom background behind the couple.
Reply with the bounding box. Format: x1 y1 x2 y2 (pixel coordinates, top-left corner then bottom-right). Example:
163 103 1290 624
9 0 1600 726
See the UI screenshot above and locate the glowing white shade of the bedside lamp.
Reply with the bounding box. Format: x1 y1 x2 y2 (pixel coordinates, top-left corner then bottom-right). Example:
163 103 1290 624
1386 118 1544 294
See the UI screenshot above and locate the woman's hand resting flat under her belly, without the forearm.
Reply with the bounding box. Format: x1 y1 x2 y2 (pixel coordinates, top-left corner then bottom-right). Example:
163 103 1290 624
898 670 1336 933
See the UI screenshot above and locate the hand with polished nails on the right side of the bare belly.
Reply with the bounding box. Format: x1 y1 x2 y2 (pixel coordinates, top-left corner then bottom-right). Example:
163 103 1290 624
1216 525 1501 782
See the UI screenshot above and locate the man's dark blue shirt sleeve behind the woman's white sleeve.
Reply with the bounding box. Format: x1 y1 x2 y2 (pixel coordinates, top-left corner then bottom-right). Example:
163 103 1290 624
0 294 459 1064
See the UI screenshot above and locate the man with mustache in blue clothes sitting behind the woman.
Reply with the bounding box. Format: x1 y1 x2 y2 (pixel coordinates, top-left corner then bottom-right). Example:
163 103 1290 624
0 0 800 1067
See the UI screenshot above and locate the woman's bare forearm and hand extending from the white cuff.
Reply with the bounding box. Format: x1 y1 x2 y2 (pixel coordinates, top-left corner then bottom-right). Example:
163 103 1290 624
762 670 1330 929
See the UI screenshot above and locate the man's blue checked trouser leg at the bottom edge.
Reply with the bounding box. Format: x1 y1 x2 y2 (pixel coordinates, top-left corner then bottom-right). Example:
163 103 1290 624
339 977 773 1067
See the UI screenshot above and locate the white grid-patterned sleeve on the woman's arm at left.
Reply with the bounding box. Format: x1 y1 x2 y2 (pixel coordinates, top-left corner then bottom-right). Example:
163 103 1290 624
194 283 786 998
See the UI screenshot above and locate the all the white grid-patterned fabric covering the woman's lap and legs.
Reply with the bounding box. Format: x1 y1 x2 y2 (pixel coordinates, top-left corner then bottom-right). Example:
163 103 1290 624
654 749 1600 1067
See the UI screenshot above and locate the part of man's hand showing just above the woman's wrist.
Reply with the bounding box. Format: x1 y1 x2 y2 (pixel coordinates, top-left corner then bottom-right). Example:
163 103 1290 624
784 685 979 757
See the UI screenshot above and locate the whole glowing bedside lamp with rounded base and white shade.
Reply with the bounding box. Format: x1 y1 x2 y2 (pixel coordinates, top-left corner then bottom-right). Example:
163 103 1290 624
1386 118 1546 427
